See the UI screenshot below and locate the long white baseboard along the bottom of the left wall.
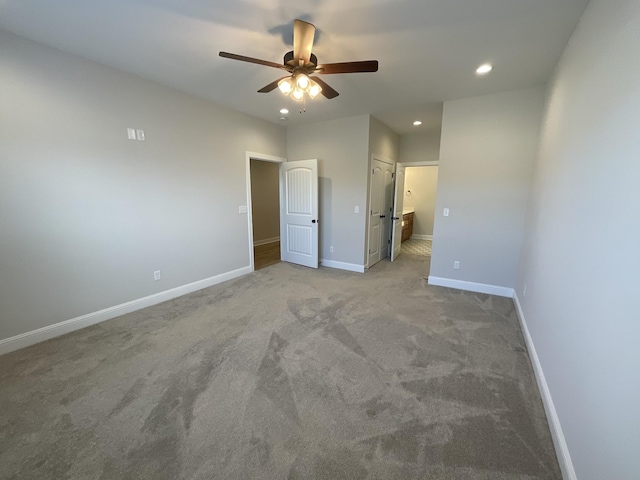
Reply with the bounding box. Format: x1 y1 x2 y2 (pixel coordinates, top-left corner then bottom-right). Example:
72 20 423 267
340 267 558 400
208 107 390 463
0 267 251 355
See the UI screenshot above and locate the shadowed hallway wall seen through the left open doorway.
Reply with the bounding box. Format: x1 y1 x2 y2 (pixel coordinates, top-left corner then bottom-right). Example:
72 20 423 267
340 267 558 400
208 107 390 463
251 159 280 244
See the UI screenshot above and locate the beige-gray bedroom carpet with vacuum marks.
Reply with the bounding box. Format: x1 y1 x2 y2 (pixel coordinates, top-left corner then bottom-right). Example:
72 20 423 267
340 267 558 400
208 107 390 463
0 256 561 480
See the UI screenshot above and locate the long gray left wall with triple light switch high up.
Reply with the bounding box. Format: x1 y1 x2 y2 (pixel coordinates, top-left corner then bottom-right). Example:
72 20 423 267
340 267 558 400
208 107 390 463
0 31 286 338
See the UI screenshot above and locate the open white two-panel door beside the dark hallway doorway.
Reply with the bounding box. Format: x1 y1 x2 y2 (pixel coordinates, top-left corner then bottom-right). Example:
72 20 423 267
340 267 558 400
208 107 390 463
280 159 319 268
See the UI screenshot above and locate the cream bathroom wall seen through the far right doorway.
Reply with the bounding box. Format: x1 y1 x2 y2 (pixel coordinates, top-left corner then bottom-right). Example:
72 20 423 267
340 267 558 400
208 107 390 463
403 166 438 235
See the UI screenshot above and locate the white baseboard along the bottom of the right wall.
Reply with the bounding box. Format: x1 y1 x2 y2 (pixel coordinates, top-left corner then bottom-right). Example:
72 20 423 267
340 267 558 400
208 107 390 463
513 293 578 480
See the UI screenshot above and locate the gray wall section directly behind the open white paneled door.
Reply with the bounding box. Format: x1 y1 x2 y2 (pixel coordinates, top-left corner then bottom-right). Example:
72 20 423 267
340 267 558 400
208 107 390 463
287 115 369 266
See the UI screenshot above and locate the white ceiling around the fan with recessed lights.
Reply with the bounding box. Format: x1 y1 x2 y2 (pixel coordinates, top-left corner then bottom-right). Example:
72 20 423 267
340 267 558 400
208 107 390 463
0 0 588 134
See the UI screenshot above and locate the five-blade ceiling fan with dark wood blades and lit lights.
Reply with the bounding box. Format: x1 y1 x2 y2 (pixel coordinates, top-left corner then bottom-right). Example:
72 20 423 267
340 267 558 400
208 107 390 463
220 19 378 100
